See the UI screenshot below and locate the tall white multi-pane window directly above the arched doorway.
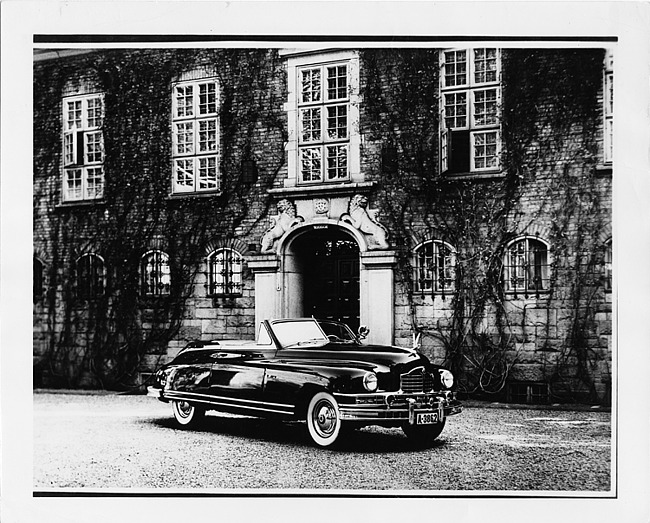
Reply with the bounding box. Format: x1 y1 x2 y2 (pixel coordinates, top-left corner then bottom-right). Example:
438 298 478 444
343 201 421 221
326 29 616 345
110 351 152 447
297 62 350 183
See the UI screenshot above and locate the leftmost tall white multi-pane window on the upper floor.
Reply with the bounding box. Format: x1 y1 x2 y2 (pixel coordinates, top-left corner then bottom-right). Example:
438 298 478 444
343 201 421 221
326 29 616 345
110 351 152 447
63 94 104 201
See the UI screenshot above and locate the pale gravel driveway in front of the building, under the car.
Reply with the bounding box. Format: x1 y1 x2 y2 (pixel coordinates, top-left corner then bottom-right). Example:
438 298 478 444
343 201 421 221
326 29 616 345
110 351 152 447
34 391 612 496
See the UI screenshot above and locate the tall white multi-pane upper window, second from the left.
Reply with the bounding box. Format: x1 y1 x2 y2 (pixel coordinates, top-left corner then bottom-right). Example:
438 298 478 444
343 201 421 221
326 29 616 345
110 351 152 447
172 78 221 193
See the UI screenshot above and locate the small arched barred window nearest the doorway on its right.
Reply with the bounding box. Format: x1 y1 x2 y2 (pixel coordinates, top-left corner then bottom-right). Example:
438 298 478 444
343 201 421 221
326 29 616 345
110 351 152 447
412 240 458 297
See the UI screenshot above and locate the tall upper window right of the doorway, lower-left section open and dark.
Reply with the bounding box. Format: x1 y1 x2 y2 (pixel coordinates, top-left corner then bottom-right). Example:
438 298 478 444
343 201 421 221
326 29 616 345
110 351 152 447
439 47 503 176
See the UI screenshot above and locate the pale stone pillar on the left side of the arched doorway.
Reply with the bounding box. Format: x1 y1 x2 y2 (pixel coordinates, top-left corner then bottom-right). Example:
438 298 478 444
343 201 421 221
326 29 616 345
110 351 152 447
246 254 280 331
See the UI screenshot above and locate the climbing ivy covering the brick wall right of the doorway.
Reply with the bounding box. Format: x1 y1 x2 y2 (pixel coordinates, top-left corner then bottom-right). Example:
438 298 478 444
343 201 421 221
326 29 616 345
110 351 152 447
362 49 610 399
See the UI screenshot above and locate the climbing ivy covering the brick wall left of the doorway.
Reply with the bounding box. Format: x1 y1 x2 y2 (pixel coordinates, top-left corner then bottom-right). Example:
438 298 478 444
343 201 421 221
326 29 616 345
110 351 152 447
34 49 286 388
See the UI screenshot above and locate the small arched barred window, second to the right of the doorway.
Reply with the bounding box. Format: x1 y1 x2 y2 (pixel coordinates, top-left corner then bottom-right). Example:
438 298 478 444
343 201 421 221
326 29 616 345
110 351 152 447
504 238 549 297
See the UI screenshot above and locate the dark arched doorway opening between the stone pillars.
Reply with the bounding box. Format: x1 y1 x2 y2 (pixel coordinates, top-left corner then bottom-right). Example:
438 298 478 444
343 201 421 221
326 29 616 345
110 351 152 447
290 226 360 331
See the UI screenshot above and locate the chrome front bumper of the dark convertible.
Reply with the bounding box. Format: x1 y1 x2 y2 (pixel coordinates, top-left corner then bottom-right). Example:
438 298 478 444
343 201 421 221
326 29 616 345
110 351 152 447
334 391 463 424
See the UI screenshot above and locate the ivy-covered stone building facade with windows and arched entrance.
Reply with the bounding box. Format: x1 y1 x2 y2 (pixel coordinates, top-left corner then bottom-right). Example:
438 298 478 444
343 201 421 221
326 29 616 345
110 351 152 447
34 47 613 403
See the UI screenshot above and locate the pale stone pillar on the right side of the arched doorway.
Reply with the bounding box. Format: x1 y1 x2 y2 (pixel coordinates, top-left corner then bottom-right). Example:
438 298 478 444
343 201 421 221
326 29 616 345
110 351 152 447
359 251 397 345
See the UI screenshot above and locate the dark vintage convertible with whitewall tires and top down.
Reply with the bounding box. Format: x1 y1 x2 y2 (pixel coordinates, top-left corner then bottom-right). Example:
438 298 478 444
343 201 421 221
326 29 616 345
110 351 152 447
148 318 462 447
